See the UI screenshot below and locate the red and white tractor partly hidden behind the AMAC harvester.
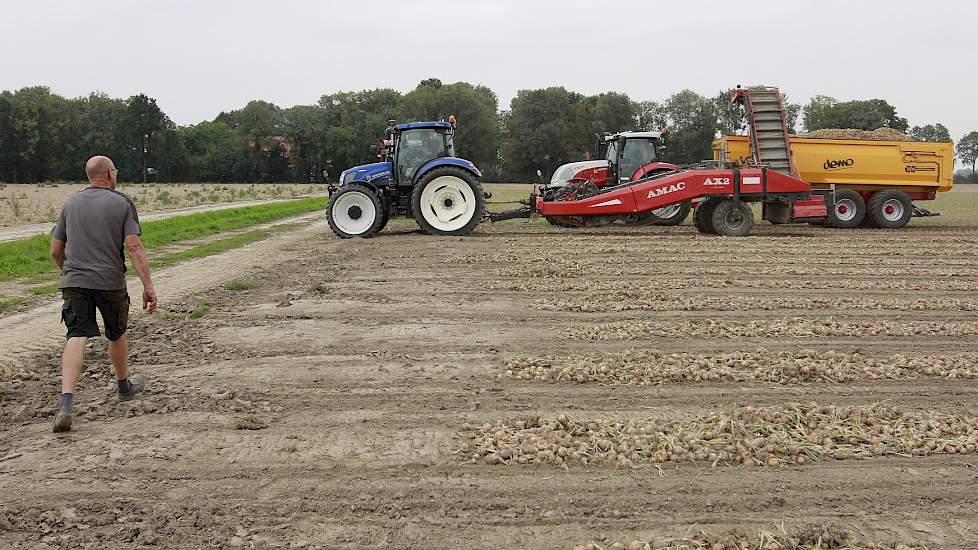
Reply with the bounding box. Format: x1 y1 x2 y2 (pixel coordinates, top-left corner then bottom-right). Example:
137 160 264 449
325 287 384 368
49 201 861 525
543 131 691 227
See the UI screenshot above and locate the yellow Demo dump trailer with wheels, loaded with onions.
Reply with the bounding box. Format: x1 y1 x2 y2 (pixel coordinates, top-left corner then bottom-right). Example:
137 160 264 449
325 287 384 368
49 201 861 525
713 136 954 228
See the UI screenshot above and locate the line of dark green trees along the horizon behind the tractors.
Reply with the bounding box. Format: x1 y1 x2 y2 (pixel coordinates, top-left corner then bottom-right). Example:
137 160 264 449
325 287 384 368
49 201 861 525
0 78 978 183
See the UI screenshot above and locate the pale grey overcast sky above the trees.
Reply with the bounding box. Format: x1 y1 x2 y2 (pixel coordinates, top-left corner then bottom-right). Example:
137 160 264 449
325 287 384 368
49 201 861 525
0 0 978 139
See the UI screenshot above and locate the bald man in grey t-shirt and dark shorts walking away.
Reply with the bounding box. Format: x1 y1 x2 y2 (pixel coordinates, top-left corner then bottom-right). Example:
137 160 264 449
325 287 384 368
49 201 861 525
51 156 156 432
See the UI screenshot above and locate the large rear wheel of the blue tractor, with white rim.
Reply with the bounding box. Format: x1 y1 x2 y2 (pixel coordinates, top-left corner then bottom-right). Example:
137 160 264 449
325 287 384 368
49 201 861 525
411 166 486 235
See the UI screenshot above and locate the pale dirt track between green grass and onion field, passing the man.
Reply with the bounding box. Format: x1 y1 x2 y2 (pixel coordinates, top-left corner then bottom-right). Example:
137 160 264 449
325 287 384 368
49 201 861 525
0 213 325 366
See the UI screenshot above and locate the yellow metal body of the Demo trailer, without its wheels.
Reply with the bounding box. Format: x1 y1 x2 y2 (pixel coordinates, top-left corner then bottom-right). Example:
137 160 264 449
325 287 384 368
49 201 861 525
713 136 954 192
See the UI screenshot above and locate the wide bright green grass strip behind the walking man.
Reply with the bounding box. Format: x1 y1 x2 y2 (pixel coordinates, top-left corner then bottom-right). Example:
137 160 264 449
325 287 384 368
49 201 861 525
0 197 328 281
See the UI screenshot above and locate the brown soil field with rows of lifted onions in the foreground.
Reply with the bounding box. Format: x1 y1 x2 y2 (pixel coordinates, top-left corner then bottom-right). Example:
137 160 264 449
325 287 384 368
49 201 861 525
0 220 978 549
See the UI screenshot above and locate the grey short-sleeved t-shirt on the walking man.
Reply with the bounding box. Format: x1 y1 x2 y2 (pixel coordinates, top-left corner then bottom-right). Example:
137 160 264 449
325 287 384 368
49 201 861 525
51 187 142 290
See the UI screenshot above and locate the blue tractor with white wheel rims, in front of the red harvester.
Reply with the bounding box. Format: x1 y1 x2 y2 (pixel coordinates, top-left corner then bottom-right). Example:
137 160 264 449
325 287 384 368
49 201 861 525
326 117 487 239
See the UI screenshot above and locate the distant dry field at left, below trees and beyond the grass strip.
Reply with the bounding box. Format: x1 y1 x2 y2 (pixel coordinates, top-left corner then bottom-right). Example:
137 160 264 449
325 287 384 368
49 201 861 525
0 182 326 227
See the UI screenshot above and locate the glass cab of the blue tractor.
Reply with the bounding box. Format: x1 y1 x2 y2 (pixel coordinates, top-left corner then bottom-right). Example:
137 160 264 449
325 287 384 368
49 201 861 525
384 121 455 185
